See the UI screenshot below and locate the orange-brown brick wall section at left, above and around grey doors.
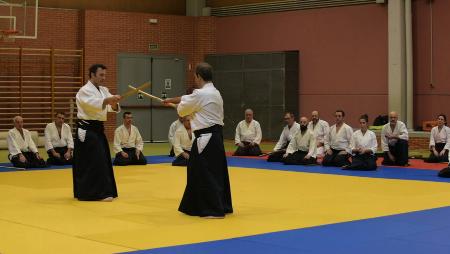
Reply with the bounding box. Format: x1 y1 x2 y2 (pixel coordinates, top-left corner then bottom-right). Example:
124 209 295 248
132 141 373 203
0 8 216 138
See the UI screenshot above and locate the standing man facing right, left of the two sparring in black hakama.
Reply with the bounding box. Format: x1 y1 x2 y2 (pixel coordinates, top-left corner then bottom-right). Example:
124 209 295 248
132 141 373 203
72 64 121 201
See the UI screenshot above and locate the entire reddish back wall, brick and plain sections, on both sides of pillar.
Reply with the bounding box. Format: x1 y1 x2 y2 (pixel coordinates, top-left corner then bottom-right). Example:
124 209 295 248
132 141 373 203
0 0 450 140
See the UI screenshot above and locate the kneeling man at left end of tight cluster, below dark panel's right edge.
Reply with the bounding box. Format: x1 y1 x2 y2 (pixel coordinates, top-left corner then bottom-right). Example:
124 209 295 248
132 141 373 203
267 112 300 162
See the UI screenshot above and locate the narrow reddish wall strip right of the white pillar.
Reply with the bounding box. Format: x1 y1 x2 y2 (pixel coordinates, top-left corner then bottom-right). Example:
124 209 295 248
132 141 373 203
413 0 450 125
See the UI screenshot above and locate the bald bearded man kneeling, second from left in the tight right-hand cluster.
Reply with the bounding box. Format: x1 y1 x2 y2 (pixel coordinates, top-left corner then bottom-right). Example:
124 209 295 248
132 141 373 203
283 117 317 165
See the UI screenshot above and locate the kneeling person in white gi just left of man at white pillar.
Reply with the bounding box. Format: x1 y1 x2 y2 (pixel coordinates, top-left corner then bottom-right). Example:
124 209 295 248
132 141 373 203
342 114 378 170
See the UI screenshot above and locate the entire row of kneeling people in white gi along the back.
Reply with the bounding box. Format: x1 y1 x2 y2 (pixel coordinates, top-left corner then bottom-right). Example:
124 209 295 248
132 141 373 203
7 109 450 177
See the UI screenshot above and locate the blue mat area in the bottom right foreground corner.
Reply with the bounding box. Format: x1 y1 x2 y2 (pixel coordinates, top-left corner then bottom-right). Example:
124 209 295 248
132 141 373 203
123 207 450 254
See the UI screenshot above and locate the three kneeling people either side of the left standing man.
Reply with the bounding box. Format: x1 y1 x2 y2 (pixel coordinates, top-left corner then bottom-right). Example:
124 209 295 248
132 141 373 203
7 112 147 168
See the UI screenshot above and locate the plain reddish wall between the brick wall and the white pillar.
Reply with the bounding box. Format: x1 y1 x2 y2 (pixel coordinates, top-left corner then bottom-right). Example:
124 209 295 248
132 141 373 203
217 4 388 127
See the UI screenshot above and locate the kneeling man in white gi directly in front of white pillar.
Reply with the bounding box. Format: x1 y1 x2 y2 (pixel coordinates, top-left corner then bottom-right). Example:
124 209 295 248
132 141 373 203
381 111 409 166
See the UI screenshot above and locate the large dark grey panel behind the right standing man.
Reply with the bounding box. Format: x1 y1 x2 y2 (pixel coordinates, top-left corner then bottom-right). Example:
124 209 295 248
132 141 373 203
206 51 299 140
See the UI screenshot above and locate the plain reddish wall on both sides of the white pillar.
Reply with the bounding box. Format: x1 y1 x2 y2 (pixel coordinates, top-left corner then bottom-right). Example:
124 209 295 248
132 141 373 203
217 0 450 127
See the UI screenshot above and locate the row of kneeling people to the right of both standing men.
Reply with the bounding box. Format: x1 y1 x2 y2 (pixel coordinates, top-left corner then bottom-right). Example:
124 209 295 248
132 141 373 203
207 109 450 177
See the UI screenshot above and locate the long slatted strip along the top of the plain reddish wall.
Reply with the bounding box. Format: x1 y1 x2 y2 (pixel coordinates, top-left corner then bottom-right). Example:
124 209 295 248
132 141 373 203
211 0 376 17
